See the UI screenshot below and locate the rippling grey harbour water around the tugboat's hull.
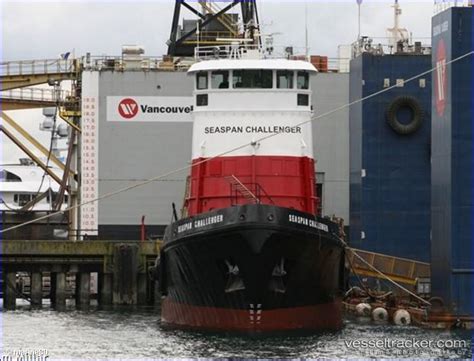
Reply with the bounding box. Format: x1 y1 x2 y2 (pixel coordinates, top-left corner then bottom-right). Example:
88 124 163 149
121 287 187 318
1 307 472 360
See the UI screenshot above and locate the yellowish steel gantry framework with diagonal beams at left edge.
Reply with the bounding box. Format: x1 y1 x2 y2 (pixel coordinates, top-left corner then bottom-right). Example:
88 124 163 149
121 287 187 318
0 59 82 237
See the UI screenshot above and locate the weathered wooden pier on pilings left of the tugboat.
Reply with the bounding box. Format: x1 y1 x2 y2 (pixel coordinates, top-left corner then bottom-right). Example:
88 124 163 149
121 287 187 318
2 240 161 310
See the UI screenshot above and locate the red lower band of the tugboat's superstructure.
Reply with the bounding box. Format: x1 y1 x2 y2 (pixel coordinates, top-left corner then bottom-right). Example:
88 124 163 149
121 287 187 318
187 156 318 216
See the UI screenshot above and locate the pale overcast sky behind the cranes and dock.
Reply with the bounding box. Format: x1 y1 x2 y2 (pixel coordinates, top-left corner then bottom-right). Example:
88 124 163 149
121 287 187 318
0 0 435 163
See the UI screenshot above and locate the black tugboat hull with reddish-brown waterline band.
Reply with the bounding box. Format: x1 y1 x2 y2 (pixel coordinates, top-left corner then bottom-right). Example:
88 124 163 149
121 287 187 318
160 205 344 330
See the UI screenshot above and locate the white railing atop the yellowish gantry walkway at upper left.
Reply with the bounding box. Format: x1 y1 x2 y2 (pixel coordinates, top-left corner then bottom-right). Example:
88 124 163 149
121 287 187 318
0 59 74 76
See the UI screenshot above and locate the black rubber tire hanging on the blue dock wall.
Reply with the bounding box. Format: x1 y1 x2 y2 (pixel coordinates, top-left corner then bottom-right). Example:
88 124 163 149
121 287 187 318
386 96 424 135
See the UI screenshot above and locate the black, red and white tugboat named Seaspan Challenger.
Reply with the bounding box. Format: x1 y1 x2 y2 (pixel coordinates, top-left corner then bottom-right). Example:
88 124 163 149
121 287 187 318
156 45 344 332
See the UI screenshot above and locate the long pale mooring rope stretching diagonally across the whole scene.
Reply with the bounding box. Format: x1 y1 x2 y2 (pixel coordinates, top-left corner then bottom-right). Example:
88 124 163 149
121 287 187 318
0 51 474 234
